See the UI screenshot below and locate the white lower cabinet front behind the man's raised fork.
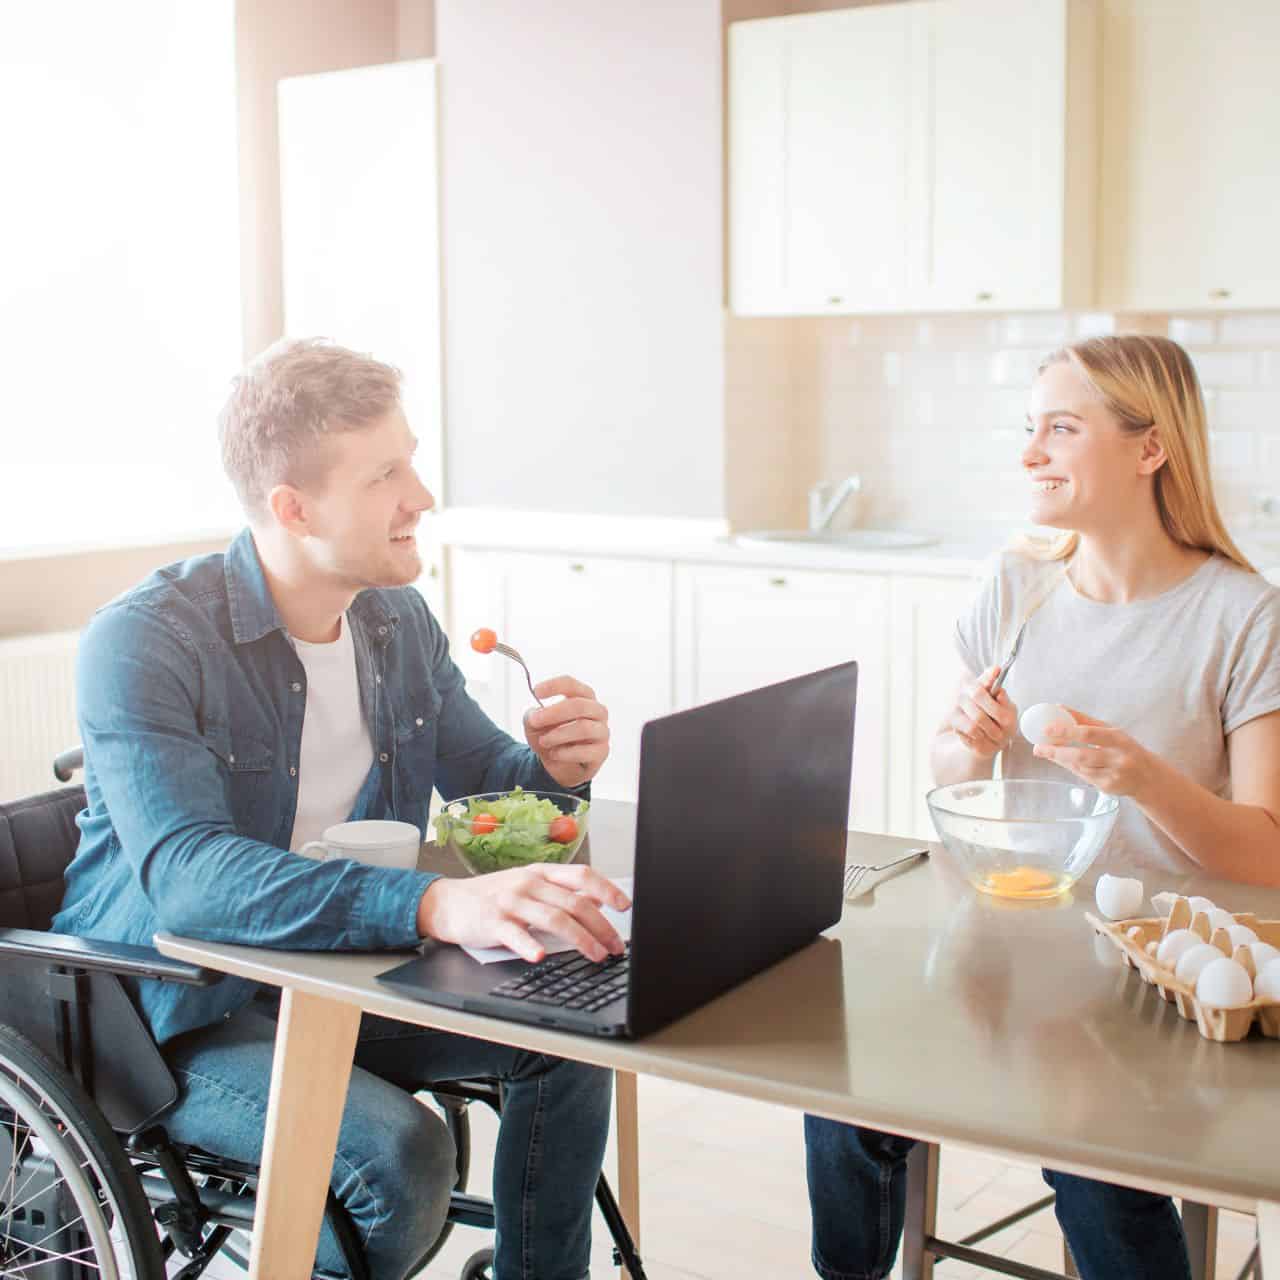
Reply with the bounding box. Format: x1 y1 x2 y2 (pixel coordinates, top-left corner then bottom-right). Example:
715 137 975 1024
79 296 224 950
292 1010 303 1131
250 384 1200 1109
451 549 673 800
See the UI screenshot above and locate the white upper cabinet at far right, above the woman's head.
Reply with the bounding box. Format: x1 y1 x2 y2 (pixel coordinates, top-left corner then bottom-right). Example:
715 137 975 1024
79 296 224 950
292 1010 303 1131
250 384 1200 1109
1098 0 1280 311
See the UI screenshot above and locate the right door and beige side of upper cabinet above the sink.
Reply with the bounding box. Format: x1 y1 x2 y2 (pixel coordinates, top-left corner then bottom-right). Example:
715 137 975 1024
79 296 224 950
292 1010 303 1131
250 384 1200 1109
927 0 1096 311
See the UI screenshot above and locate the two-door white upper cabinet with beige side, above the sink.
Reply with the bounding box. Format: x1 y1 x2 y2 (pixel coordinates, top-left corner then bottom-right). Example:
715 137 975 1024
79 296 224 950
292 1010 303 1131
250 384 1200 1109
728 0 1096 315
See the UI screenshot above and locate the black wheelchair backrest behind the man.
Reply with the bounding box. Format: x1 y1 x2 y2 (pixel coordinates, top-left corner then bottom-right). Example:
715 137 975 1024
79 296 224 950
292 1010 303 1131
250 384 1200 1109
0 787 84 929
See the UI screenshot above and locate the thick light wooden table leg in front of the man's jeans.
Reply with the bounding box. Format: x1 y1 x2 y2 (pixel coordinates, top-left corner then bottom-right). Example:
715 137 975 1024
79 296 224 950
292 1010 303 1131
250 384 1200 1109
250 988 360 1280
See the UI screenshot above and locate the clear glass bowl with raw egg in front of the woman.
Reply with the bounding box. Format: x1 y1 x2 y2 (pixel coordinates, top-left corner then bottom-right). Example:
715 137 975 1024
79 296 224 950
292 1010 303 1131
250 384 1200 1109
925 778 1120 899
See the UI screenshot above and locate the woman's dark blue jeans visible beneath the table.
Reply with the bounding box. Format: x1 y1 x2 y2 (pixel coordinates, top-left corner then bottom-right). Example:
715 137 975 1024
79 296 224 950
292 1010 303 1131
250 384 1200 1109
804 1116 1190 1280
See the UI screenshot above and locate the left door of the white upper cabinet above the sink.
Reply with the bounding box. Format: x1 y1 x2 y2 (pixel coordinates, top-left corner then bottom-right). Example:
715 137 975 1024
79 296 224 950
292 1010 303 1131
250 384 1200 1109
728 4 920 315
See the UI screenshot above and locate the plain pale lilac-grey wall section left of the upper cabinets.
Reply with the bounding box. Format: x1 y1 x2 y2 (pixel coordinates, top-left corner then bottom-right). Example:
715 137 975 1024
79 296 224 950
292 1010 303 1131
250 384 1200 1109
435 0 724 517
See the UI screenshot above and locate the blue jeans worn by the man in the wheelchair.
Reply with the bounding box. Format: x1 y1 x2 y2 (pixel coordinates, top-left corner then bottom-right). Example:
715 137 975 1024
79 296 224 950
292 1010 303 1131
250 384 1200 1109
161 1005 613 1280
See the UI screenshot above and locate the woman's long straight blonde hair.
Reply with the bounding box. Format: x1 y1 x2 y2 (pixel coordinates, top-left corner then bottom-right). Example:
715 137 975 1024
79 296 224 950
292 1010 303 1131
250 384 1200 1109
1018 333 1257 572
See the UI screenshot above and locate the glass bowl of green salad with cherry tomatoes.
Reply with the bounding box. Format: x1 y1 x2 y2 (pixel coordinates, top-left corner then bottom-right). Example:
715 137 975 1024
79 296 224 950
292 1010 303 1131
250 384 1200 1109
435 787 590 876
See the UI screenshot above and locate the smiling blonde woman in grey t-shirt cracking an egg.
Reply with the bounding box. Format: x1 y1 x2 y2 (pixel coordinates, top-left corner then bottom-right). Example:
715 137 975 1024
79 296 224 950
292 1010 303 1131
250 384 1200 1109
805 335 1280 1280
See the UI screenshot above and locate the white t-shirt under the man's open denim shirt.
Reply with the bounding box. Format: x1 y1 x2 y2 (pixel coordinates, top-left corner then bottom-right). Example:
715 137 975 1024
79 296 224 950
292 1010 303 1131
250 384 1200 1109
289 614 374 851
